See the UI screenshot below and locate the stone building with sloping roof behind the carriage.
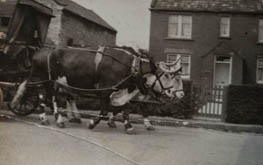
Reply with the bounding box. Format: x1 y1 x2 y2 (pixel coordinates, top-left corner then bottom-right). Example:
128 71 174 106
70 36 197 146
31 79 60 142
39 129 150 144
0 0 117 46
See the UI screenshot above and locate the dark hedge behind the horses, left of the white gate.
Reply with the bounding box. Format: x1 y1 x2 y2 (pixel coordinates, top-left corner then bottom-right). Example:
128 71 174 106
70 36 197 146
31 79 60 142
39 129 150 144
78 81 195 119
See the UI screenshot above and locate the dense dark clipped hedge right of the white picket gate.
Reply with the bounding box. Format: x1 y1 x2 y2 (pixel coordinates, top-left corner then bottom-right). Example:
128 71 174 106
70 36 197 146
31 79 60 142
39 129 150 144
226 85 263 124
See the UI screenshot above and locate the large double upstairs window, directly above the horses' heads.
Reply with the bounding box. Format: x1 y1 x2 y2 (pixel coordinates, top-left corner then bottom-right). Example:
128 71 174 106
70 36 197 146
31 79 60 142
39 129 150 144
168 15 192 39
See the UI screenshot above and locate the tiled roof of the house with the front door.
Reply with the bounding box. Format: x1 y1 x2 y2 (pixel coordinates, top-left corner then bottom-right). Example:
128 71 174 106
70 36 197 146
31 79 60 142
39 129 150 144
151 0 263 13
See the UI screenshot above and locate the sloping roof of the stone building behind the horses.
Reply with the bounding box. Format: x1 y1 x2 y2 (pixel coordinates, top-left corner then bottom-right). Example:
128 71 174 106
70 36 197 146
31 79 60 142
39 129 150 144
55 0 117 32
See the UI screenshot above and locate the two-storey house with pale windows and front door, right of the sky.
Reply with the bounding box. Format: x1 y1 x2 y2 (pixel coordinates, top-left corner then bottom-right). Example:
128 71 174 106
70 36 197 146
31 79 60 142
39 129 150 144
149 0 263 87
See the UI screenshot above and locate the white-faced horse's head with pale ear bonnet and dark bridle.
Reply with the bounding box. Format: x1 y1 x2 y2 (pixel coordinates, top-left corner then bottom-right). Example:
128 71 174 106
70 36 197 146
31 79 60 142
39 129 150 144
144 57 184 99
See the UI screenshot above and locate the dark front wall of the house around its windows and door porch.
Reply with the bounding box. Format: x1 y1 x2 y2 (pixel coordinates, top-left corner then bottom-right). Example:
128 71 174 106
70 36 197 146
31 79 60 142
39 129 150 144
149 11 263 84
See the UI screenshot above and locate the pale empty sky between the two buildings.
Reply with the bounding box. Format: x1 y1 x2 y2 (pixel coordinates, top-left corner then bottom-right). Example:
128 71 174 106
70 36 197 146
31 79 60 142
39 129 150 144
73 0 151 49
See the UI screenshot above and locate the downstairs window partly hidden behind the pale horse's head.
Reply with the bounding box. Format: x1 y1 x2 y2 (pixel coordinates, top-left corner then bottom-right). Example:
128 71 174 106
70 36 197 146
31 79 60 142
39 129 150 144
167 54 191 79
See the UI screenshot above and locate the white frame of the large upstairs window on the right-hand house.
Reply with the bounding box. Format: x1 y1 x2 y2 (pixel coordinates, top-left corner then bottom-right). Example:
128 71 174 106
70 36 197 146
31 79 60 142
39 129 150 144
167 15 193 39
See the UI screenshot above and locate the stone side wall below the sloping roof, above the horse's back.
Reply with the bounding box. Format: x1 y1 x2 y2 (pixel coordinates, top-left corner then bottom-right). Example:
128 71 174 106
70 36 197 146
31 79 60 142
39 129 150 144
60 11 116 46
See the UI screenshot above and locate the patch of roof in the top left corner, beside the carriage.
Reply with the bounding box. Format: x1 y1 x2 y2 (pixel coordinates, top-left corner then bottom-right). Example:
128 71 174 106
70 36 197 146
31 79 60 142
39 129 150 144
0 0 16 17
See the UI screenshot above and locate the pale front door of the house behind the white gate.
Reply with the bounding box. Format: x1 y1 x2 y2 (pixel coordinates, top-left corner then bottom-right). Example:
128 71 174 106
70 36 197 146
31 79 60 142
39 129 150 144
214 56 232 86
